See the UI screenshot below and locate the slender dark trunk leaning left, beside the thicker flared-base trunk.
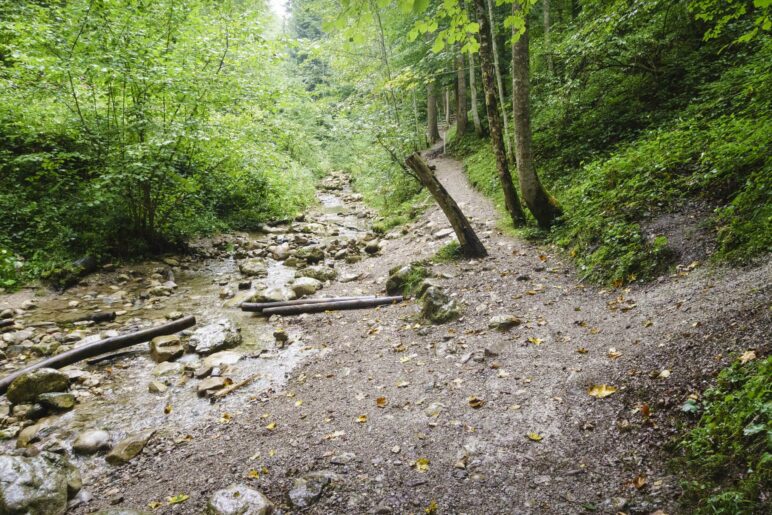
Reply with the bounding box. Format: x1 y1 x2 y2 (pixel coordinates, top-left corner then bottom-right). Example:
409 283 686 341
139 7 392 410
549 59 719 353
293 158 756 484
475 0 525 227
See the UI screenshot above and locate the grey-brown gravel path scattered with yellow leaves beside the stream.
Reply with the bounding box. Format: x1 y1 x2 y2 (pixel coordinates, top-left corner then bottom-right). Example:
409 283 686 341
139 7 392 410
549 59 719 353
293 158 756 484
3 147 772 514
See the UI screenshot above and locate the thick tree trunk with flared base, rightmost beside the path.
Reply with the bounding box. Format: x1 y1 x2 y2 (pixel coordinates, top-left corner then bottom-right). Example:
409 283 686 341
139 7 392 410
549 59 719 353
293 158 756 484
512 0 563 228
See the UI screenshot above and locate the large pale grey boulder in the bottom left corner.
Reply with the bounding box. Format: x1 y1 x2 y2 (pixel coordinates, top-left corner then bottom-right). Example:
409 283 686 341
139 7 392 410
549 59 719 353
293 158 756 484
0 452 81 515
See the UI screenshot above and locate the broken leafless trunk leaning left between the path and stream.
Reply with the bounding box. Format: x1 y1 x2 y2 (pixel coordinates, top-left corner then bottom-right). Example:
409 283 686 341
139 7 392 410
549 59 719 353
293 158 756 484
405 153 488 258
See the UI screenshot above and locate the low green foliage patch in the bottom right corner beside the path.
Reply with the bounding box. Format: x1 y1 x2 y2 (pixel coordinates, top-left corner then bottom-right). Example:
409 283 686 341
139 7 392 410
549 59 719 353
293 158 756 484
674 357 772 514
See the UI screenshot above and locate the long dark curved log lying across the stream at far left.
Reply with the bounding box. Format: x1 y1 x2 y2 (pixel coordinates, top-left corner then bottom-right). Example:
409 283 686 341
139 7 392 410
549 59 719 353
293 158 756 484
0 316 196 395
